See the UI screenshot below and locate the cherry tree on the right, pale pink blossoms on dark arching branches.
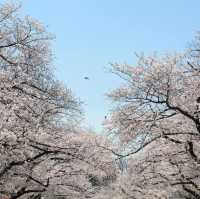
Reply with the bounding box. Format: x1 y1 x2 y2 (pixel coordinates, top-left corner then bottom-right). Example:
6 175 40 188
106 36 200 198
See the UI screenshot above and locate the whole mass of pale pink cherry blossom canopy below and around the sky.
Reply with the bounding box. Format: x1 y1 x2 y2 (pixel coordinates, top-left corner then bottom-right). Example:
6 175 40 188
0 3 200 199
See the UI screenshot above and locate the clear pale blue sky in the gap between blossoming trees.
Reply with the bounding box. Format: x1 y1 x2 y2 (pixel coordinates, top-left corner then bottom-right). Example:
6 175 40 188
12 0 200 130
